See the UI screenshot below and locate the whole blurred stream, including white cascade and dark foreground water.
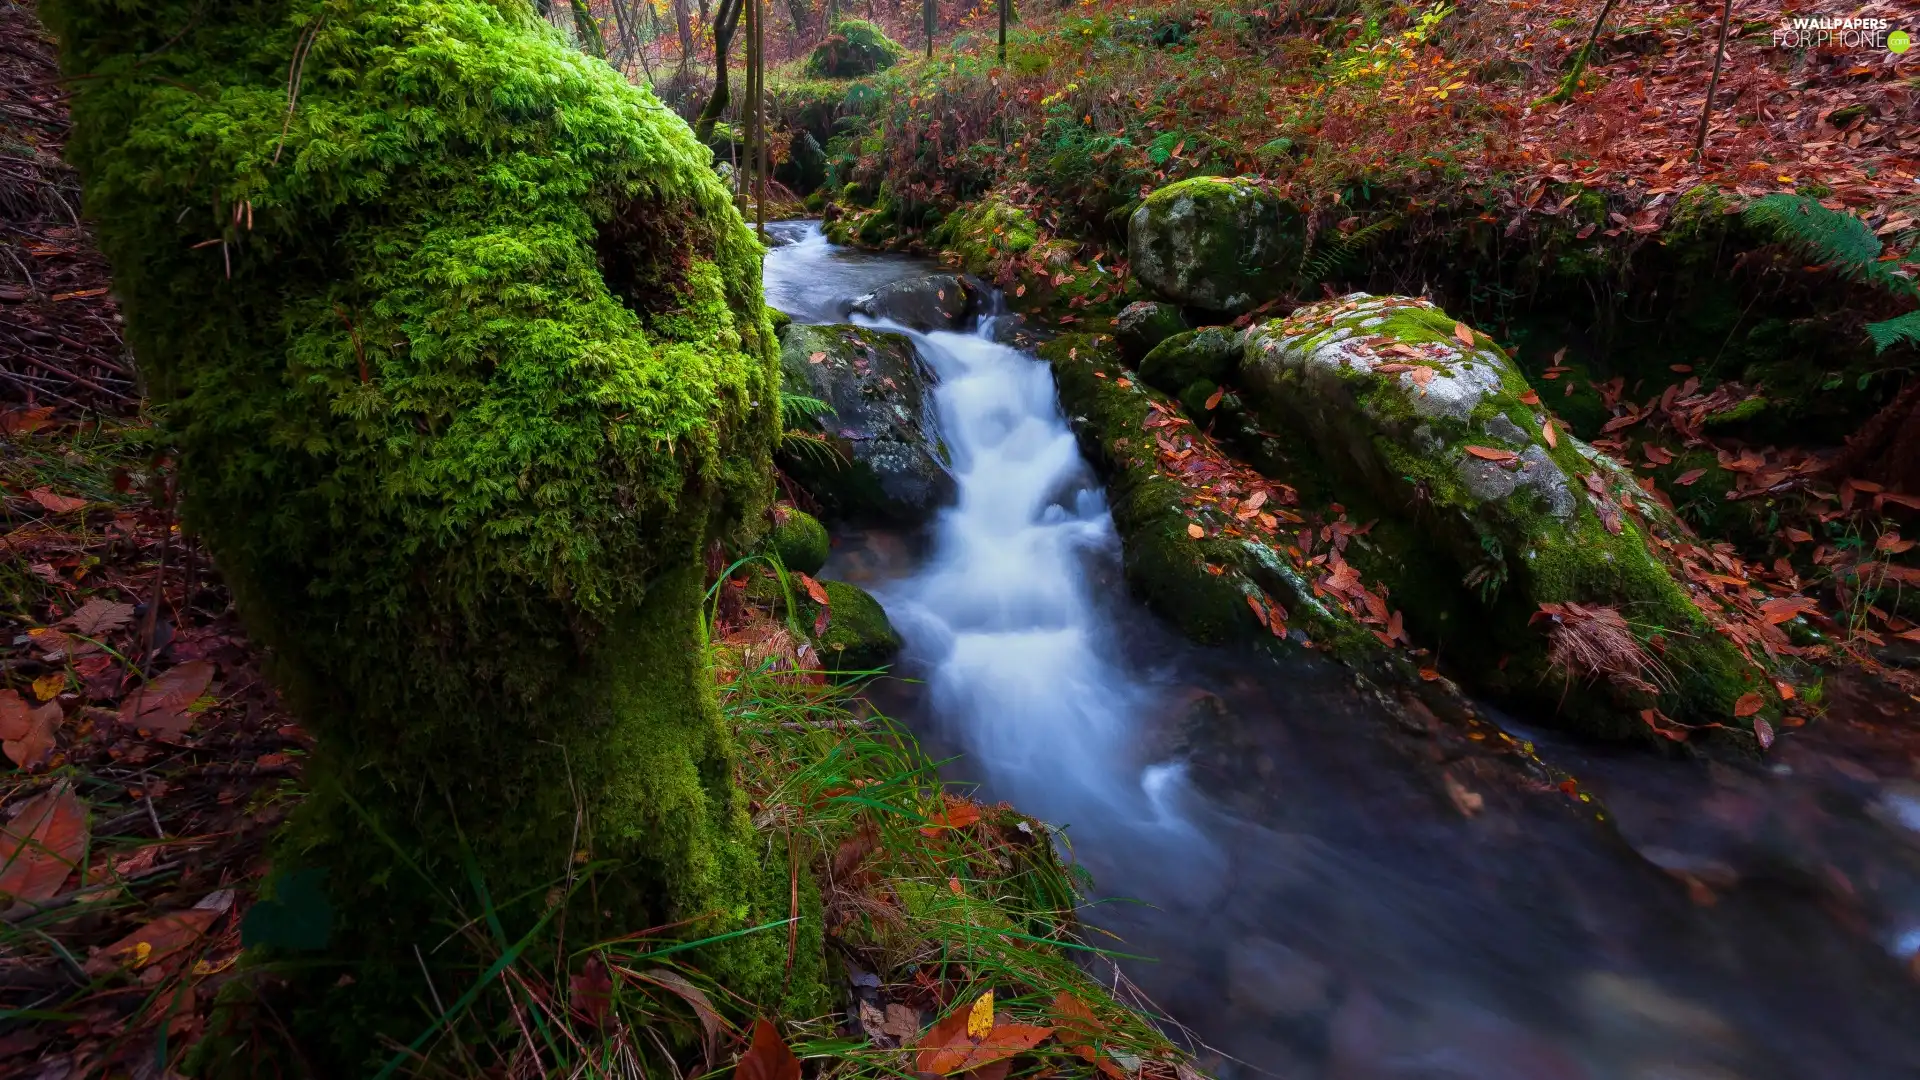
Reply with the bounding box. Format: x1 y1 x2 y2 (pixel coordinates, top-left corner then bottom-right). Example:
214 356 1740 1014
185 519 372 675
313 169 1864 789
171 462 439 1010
766 223 1920 1080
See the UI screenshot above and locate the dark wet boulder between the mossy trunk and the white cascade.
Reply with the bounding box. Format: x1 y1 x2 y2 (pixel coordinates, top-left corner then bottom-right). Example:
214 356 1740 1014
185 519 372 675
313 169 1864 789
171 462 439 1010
780 323 954 525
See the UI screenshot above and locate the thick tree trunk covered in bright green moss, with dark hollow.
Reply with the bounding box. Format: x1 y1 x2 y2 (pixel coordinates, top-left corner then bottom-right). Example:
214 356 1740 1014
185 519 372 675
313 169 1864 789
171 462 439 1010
44 0 820 1055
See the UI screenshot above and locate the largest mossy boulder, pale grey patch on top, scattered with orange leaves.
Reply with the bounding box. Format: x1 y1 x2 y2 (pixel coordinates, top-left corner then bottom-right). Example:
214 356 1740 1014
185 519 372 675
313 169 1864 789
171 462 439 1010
1236 294 1776 734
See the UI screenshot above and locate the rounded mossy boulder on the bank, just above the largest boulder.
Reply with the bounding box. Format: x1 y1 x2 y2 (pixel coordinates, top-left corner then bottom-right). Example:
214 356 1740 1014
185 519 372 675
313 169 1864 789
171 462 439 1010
1127 177 1306 313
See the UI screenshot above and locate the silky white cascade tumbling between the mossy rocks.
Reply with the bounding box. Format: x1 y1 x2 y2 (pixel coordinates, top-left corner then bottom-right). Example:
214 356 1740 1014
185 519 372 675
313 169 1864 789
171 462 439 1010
844 303 1206 853
